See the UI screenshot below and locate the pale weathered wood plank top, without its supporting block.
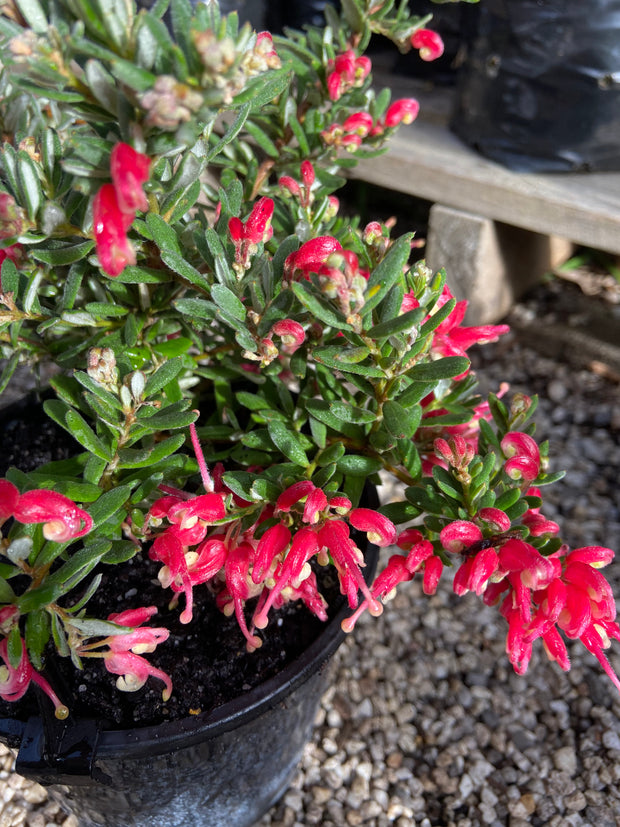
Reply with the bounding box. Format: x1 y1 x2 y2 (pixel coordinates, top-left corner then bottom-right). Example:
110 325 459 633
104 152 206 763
352 79 620 254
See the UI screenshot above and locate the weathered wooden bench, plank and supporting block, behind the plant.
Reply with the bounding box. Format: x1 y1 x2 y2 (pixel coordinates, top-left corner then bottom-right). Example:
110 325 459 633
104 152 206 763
351 77 620 324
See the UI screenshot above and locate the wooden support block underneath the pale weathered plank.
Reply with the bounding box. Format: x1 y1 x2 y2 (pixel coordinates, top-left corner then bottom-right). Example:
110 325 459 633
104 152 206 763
426 204 573 325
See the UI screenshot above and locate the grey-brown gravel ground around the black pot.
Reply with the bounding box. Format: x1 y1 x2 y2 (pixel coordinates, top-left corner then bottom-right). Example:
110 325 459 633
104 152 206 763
0 282 620 827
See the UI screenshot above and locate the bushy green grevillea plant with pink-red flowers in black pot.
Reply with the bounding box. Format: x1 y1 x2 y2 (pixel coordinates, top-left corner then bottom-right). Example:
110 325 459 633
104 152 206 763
0 0 620 717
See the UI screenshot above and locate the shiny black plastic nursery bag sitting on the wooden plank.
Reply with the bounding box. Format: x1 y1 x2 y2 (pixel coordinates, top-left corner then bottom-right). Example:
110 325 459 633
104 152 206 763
452 0 620 172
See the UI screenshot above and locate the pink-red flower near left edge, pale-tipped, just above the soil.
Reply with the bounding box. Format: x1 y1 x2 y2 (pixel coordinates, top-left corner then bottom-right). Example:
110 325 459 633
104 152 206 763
13 489 93 543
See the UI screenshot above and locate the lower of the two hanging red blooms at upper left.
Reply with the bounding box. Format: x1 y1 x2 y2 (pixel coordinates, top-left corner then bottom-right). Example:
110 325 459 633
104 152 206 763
93 184 136 276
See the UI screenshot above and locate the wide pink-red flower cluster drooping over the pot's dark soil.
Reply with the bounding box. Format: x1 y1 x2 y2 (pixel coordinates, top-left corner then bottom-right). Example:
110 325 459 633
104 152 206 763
145 426 396 651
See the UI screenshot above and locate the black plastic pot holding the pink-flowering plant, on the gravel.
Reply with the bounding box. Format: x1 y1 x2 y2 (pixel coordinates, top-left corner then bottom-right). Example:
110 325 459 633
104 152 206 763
0 516 378 827
